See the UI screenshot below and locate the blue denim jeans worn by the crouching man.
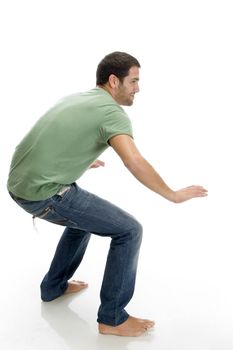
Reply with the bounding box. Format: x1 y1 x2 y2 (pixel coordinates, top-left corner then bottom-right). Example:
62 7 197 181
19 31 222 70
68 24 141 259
11 183 142 326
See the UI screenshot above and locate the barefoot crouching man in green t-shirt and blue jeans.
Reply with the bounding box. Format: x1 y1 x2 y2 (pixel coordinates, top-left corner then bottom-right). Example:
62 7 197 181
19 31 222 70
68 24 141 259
8 52 207 336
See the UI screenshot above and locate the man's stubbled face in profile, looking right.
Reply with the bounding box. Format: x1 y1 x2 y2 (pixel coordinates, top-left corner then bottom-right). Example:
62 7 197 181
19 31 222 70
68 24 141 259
114 66 139 106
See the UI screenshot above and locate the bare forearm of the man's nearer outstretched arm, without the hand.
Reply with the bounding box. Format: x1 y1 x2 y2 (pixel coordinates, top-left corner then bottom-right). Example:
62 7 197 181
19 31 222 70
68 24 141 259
124 155 175 202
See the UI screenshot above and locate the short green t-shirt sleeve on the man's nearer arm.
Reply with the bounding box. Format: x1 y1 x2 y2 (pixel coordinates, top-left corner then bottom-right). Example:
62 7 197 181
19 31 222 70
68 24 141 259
100 112 133 143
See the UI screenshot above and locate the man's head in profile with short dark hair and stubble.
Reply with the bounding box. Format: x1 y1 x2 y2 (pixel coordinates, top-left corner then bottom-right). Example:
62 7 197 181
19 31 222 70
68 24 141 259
96 51 140 106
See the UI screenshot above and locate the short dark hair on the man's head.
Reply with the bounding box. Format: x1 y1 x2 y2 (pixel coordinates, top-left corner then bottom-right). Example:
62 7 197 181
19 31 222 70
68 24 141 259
96 51 141 85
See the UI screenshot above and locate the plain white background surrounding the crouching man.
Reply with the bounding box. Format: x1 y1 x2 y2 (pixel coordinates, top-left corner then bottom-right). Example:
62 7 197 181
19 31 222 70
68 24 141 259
0 0 233 350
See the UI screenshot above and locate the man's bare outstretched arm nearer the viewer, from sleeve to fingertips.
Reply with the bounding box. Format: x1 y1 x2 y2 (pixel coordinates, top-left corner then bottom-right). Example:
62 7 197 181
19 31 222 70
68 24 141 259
109 135 207 203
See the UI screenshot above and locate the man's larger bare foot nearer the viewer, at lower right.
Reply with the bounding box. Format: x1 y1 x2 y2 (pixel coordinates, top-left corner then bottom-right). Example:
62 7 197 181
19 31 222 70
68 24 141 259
99 316 155 337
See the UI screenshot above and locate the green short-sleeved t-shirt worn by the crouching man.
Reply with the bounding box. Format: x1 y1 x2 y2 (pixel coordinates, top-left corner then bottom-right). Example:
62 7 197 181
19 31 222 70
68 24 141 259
7 87 132 200
